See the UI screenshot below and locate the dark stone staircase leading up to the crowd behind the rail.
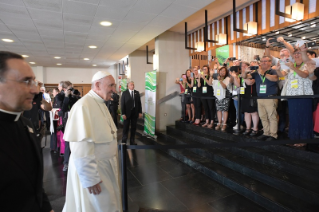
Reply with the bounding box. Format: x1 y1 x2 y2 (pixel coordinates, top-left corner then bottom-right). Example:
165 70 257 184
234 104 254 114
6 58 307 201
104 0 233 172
137 121 319 212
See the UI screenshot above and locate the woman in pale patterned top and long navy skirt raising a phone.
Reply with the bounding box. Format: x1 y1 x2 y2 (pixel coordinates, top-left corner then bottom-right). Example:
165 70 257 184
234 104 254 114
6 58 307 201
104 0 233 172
276 46 313 147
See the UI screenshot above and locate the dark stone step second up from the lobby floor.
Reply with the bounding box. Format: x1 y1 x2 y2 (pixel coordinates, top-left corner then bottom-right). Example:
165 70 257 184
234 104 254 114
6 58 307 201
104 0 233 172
162 129 319 204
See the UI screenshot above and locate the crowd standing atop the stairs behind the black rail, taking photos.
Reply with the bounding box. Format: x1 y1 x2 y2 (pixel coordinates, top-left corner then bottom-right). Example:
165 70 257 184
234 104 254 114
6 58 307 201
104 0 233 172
176 37 319 147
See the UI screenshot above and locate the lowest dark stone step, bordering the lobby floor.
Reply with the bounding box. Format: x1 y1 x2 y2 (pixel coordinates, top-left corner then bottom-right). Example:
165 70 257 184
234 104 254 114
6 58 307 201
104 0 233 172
156 135 318 212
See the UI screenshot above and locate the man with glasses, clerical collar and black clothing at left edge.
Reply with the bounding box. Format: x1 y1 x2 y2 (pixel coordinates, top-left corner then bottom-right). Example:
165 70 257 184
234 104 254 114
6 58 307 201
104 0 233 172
0 51 53 212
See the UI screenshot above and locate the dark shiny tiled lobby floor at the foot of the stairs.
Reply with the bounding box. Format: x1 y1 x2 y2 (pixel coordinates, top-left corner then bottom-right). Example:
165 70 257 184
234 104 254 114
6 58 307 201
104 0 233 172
43 131 267 212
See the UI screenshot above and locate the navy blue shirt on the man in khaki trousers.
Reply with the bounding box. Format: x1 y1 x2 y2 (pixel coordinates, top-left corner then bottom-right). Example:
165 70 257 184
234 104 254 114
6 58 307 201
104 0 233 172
251 69 278 97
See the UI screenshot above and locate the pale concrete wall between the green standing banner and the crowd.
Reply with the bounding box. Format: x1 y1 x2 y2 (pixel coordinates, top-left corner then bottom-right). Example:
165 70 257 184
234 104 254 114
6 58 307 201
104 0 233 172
155 31 189 131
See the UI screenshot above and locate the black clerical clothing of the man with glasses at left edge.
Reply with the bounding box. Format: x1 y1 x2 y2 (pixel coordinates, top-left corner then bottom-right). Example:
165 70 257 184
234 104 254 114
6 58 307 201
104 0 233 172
0 111 51 212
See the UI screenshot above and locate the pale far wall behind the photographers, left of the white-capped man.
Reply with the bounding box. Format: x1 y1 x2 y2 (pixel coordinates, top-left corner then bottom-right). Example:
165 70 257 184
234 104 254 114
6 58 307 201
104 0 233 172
32 66 117 84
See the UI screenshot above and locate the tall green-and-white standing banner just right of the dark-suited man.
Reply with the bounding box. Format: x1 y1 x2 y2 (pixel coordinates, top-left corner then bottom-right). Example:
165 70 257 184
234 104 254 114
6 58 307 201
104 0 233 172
144 71 156 137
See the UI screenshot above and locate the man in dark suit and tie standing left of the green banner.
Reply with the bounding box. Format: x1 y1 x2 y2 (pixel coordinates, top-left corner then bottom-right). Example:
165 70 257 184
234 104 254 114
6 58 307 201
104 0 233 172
121 81 142 145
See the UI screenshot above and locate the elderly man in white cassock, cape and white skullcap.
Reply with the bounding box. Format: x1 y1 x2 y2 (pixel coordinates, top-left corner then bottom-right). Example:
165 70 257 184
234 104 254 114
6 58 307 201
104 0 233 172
63 71 122 212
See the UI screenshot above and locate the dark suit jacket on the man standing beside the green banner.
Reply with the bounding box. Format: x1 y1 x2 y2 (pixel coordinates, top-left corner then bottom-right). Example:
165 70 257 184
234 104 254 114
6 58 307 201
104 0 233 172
121 90 142 118
